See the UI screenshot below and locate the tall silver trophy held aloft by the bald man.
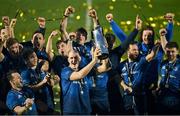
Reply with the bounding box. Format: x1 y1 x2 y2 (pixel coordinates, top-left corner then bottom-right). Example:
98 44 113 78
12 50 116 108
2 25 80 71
93 26 109 60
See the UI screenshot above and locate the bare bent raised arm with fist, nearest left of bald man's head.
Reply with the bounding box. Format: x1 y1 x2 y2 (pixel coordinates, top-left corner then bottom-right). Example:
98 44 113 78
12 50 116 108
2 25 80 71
46 30 59 61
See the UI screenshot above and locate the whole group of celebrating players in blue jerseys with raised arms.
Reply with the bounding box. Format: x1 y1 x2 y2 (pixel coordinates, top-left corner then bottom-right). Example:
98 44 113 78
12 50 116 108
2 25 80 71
0 6 180 115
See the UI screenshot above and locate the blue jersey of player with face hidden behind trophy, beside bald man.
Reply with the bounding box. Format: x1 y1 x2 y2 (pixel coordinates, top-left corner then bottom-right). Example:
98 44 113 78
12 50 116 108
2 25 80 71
90 72 110 113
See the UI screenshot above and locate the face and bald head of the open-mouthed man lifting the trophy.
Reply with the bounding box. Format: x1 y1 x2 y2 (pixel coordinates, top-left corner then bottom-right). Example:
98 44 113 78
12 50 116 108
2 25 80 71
68 50 81 70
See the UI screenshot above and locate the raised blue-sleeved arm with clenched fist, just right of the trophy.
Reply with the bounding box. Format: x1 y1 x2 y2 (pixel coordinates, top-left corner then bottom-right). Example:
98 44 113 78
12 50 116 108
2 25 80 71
106 13 127 42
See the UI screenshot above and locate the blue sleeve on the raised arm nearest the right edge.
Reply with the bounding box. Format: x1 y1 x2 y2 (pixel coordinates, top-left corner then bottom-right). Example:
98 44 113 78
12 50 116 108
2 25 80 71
166 22 174 42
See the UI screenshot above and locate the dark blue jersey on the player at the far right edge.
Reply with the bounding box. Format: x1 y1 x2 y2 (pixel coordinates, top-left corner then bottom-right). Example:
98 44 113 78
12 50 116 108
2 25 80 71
157 58 180 115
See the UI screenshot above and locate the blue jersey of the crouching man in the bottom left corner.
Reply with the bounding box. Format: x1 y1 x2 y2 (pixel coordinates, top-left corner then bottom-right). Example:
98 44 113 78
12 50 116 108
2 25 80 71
6 88 37 115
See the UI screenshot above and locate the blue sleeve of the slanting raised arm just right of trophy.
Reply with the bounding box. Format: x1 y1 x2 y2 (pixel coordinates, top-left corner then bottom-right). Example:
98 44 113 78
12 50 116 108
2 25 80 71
110 20 127 42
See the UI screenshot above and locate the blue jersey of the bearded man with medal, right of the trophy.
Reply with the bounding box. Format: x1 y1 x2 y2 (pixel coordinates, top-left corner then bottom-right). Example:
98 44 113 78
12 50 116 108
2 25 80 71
119 57 148 94
